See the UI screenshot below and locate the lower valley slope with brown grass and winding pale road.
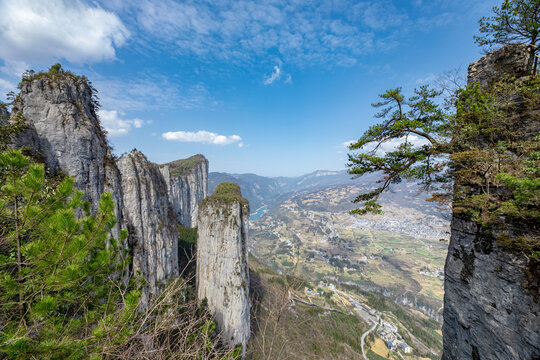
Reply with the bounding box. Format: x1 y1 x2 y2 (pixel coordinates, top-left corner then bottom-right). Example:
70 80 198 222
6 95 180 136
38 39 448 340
247 256 442 360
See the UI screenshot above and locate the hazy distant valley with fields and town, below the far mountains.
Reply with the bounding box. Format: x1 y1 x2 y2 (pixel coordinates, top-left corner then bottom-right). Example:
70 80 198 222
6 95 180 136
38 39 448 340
209 171 450 322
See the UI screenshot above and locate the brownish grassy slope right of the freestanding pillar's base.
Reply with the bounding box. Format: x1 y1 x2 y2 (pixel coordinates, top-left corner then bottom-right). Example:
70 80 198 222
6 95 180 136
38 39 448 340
247 258 365 360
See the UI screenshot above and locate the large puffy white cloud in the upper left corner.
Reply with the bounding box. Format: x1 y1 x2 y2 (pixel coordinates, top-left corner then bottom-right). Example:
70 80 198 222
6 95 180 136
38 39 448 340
0 0 129 64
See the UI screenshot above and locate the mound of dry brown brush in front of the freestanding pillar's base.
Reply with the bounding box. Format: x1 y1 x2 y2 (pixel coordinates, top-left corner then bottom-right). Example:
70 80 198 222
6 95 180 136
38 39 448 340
96 262 236 360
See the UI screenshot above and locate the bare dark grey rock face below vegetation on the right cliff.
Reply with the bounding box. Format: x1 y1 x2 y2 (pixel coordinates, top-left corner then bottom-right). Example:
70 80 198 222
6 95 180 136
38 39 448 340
443 216 540 360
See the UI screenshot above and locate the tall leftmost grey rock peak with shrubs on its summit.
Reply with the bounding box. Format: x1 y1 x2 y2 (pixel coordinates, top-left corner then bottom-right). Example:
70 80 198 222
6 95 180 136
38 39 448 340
12 76 114 212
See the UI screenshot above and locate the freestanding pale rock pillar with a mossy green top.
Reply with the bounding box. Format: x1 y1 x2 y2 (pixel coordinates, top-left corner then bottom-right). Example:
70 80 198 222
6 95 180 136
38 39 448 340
197 183 250 354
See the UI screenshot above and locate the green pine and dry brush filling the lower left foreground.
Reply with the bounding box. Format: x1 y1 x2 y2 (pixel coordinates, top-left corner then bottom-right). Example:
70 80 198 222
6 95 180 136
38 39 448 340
0 150 239 359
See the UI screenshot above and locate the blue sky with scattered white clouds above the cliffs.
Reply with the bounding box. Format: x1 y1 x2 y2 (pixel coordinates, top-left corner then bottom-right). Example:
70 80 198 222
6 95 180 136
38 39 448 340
0 0 499 176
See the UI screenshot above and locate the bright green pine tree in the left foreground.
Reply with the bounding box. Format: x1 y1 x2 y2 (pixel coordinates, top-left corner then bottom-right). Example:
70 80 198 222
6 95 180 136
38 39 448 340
0 150 138 359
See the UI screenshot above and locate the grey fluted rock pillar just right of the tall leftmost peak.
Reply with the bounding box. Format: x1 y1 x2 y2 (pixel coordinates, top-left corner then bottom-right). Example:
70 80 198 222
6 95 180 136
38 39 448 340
118 150 178 303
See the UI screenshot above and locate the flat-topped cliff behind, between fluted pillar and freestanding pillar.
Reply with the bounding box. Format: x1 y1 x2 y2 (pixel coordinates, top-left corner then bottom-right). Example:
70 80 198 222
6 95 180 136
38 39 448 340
159 154 208 228
